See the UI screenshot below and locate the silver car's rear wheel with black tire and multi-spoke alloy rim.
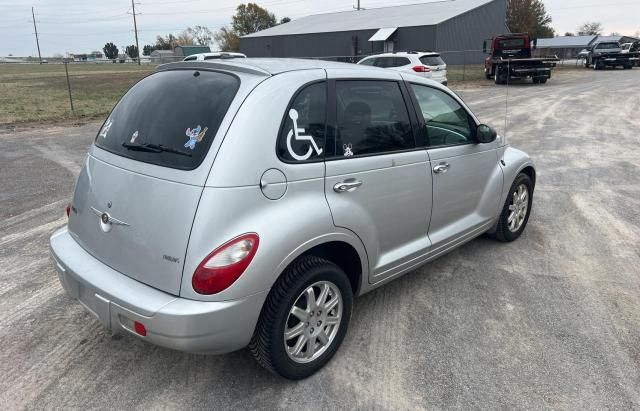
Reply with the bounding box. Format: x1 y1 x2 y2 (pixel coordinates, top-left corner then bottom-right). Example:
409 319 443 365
249 256 353 380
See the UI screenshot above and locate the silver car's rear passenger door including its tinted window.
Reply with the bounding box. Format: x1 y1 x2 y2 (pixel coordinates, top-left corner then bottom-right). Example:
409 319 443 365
325 72 431 282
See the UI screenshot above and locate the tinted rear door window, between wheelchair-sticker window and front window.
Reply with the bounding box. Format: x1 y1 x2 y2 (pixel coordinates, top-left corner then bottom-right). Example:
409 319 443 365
335 80 415 157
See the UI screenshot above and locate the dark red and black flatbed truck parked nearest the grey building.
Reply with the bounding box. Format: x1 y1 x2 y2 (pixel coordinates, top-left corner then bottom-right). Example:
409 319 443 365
482 33 559 84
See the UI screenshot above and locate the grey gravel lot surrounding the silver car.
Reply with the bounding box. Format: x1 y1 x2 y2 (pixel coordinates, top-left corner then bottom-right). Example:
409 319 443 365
0 69 640 409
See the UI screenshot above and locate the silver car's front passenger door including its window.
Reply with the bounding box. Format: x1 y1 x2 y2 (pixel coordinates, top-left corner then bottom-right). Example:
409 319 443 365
409 84 503 249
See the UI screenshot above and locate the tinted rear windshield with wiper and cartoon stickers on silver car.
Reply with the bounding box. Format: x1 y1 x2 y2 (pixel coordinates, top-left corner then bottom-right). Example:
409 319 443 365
95 70 240 170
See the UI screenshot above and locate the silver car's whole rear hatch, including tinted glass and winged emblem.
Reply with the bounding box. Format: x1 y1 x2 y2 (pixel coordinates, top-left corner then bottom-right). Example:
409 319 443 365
69 69 239 295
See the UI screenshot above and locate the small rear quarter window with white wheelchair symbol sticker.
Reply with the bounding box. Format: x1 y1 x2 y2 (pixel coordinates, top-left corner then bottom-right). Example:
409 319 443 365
276 82 327 162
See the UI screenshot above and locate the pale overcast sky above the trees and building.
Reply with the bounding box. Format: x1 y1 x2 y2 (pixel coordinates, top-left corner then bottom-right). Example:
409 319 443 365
0 0 640 56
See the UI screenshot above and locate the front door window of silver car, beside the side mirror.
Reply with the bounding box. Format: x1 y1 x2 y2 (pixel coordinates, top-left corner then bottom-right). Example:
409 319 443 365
411 84 474 147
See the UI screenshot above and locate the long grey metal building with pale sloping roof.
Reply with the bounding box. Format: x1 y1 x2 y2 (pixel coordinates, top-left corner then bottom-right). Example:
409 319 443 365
240 0 507 64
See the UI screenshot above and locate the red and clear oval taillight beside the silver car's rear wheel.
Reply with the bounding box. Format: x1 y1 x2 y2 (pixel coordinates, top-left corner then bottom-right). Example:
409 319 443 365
191 233 260 295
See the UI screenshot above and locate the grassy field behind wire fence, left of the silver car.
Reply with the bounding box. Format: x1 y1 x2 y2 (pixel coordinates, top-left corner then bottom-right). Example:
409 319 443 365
0 63 155 125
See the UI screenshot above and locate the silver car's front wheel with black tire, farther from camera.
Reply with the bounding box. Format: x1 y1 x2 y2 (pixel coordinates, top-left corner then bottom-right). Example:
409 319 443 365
493 173 533 242
